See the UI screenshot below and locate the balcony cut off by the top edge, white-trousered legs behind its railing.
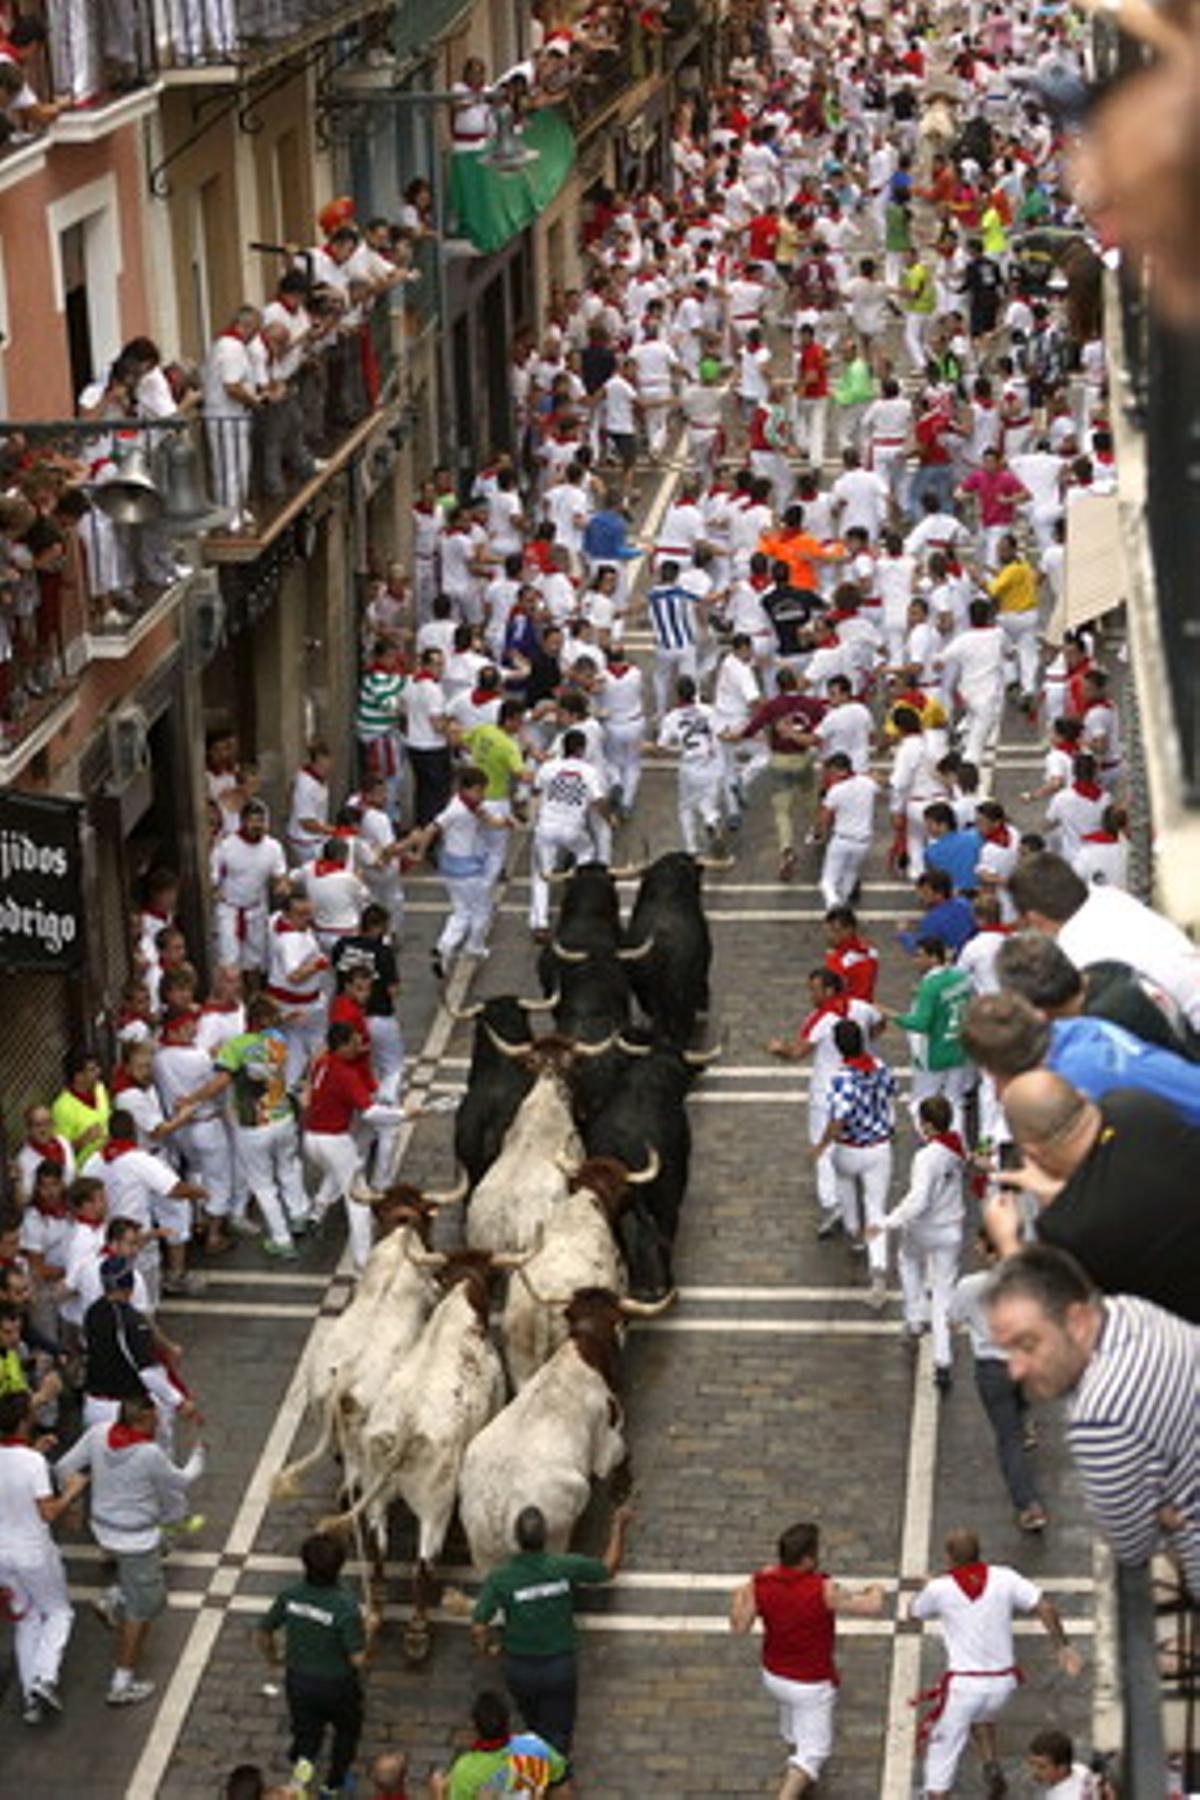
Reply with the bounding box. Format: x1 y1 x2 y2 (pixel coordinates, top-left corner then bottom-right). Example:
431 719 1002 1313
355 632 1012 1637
153 0 380 81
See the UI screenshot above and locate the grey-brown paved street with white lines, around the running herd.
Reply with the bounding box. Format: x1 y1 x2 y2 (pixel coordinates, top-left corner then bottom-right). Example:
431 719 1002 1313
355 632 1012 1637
0 565 1092 1800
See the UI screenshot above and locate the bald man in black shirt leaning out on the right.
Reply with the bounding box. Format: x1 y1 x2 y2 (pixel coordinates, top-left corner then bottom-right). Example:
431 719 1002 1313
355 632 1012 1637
986 1069 1200 1325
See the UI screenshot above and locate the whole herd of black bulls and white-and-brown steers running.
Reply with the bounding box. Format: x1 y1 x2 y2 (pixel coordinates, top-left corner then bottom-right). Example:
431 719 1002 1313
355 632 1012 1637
275 851 723 1658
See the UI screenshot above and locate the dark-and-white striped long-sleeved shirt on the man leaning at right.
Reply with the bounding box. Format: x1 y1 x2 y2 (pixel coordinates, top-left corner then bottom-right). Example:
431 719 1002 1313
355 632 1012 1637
1067 1294 1200 1593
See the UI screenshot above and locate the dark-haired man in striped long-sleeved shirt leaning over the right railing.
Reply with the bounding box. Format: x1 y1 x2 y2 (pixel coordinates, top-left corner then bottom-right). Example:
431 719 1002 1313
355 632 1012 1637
986 1244 1200 1595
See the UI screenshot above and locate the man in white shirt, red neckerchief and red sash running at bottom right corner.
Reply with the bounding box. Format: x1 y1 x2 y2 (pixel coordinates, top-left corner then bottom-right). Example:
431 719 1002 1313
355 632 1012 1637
909 1530 1083 1800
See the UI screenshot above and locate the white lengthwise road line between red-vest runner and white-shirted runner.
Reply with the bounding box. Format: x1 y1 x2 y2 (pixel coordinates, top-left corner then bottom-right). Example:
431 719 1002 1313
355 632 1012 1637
880 1337 941 1800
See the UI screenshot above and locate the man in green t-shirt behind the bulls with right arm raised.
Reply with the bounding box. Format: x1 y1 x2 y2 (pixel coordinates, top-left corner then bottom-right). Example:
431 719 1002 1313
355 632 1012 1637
471 1507 633 1757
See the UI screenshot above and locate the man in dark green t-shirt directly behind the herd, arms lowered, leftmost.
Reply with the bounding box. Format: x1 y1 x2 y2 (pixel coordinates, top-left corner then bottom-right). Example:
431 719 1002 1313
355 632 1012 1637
255 1532 378 1793
